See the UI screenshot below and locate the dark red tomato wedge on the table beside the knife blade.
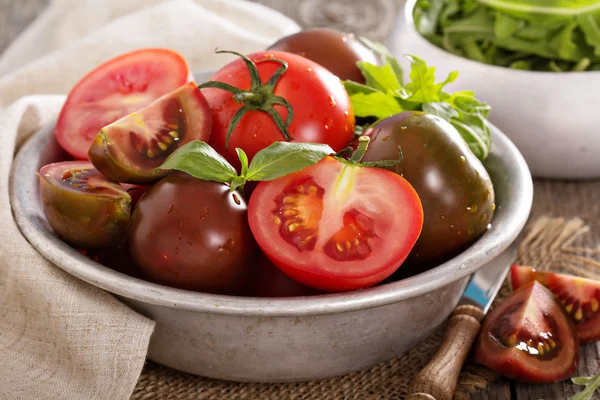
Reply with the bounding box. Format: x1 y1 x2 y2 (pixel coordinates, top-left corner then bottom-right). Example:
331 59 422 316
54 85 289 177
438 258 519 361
475 282 579 383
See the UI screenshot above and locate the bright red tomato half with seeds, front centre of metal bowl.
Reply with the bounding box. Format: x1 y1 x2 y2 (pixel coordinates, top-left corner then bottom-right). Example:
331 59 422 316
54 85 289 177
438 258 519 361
248 157 423 291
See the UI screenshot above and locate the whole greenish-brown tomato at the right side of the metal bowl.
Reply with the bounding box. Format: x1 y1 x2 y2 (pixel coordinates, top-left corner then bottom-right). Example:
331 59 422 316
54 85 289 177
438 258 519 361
363 112 496 270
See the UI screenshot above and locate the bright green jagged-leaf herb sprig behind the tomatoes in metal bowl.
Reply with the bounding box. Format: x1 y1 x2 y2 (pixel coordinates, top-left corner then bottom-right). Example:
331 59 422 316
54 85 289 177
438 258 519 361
343 38 492 160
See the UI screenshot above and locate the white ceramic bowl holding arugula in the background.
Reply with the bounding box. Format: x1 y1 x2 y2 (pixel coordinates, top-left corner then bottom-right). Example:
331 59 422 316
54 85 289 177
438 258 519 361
387 0 600 179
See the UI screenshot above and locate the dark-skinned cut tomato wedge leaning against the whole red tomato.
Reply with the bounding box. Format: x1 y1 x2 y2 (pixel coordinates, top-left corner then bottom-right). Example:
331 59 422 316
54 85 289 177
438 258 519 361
88 82 212 183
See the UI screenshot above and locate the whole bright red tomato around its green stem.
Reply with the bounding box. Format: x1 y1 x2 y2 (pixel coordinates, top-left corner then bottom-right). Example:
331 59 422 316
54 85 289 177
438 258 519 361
202 51 354 169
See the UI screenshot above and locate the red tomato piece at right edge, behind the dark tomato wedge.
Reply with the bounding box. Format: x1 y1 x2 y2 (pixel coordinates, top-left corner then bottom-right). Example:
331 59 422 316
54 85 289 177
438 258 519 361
511 265 600 343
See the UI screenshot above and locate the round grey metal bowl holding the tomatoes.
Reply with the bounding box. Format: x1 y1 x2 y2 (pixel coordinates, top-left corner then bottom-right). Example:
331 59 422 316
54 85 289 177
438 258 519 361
11 70 533 382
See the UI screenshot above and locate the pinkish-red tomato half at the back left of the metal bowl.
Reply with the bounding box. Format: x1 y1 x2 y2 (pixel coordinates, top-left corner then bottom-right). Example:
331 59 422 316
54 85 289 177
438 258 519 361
56 49 193 160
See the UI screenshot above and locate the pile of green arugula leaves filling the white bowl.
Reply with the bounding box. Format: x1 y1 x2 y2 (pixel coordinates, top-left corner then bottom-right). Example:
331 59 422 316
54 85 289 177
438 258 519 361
413 0 600 72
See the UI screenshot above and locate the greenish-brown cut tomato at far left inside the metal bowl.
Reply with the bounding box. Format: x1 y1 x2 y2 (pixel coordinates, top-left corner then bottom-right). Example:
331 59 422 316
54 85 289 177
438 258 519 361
38 161 131 249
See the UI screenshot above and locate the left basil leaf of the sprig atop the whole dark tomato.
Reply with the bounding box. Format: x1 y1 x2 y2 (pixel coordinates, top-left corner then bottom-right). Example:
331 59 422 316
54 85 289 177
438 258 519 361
158 140 238 183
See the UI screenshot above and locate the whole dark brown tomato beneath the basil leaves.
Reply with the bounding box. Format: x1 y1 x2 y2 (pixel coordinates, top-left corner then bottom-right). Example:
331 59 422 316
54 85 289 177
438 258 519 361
129 172 257 294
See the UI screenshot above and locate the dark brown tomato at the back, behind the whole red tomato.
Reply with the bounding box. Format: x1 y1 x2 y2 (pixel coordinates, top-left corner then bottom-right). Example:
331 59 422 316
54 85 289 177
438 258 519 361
269 28 378 83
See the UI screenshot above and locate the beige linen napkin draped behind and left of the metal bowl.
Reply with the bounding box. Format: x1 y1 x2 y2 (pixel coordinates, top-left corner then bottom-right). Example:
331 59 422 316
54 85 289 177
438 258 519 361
0 0 298 400
